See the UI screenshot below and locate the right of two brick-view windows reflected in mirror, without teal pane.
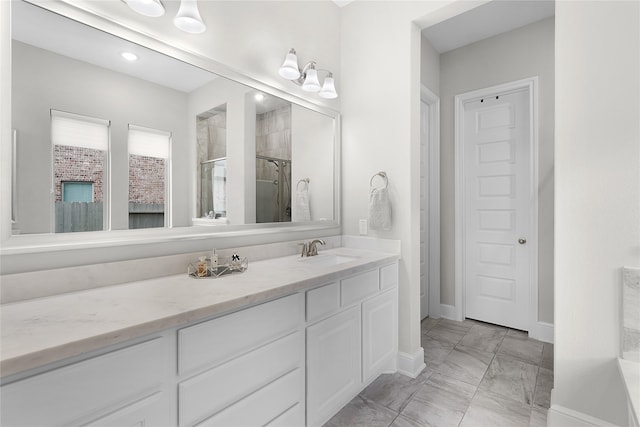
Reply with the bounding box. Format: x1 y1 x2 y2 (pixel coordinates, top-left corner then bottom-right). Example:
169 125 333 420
129 125 171 229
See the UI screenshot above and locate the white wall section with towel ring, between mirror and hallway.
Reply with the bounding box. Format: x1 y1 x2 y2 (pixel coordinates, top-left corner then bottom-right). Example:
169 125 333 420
341 1 456 368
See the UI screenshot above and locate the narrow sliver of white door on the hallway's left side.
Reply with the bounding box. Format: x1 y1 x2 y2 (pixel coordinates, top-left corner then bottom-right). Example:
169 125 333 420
420 102 430 319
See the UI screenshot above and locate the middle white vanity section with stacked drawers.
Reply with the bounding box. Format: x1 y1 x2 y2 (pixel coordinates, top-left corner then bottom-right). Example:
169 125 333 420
178 294 304 427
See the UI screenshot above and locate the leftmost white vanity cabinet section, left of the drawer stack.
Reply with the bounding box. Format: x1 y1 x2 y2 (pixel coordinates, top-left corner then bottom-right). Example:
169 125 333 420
0 336 175 426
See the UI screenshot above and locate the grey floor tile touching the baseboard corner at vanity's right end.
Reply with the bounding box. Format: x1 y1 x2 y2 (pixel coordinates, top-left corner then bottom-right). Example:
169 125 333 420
360 372 428 412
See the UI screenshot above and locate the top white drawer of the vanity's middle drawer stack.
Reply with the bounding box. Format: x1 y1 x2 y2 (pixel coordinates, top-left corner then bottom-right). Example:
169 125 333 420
178 294 303 375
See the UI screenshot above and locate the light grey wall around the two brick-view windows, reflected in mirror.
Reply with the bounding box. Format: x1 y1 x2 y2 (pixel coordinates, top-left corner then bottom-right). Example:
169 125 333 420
11 42 189 233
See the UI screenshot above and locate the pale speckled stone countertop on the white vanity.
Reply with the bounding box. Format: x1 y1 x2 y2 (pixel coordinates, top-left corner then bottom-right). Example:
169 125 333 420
0 248 399 377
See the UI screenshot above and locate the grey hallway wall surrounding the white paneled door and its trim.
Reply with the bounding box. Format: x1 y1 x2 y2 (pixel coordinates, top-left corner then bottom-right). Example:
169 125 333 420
440 18 554 323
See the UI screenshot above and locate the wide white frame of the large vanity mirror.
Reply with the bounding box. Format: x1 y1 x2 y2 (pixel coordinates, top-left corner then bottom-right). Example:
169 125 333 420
0 0 341 268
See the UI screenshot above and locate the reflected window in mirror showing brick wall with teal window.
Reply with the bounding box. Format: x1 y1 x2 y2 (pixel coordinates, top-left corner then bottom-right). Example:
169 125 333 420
51 110 109 233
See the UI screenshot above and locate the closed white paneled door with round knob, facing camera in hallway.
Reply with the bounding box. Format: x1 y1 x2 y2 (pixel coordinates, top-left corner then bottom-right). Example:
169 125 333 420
462 90 531 330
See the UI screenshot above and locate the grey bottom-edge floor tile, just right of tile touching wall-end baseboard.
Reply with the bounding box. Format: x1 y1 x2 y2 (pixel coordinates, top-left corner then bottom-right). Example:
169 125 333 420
400 373 476 427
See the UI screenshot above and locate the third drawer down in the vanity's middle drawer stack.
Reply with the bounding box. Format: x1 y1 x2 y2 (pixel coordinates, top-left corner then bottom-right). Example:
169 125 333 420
198 368 304 427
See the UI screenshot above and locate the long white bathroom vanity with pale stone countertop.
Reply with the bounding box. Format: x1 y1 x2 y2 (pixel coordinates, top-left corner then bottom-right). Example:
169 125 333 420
0 248 398 427
